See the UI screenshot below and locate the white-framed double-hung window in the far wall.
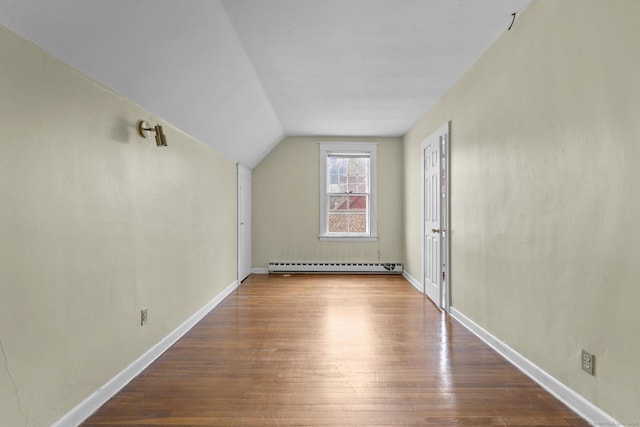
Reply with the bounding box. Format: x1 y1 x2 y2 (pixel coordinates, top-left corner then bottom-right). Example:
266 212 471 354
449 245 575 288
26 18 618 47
320 142 378 240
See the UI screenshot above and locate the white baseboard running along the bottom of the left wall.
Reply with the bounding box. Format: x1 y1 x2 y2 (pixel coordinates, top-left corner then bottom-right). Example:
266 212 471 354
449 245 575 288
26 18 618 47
51 280 238 427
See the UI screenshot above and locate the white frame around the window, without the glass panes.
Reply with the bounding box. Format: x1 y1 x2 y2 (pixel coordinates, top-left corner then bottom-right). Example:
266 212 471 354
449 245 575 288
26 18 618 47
319 142 378 242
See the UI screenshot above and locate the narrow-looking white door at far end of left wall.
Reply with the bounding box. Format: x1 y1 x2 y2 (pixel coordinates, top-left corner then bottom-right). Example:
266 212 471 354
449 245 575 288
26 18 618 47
238 164 251 282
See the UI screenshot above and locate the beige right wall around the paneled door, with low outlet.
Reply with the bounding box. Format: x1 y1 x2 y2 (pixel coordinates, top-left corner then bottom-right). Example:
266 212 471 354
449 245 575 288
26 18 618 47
405 0 640 423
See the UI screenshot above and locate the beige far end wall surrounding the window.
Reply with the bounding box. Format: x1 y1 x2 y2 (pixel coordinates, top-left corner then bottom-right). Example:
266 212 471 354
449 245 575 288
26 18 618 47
252 137 404 268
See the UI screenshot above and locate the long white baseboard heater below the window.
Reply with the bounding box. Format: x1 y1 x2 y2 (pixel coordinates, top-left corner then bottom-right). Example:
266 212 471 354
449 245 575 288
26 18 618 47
269 262 402 274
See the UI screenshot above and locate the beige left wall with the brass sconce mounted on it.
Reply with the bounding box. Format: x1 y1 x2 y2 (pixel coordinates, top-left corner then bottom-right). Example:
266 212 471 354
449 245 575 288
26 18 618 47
0 27 236 427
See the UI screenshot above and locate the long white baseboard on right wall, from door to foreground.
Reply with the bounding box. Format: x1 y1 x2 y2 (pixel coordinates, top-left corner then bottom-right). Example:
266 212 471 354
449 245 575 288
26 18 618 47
450 307 622 426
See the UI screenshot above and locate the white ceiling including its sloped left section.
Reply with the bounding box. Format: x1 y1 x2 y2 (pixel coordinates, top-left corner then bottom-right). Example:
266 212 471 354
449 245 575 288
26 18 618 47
0 0 530 167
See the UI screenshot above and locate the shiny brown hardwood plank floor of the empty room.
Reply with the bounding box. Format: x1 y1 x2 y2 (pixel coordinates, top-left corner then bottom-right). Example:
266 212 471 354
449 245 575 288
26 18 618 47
83 275 589 426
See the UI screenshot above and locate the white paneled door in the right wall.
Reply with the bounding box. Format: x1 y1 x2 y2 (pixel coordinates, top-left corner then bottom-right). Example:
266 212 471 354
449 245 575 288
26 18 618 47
422 123 449 310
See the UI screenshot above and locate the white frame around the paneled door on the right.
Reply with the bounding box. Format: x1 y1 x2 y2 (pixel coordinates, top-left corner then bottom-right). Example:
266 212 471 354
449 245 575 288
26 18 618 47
420 121 451 312
